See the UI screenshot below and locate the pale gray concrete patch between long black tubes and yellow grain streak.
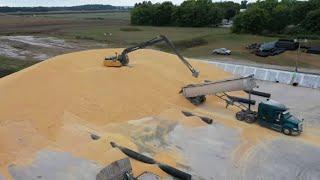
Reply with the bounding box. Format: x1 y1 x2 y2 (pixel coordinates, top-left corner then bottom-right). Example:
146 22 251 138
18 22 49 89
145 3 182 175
168 124 240 179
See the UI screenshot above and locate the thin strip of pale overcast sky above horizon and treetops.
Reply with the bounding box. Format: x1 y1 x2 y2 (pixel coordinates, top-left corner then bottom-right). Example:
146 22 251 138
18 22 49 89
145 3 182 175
0 0 253 6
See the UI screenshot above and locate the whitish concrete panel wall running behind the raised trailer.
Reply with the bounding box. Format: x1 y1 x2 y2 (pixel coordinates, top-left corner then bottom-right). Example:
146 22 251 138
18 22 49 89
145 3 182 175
208 61 320 88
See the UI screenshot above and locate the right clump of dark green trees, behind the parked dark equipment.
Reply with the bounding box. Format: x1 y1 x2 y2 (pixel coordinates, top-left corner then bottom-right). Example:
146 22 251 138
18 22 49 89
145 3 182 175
232 0 320 35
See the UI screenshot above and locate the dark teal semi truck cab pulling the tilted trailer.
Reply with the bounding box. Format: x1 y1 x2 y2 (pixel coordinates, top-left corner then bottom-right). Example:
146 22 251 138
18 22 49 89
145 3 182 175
257 99 302 135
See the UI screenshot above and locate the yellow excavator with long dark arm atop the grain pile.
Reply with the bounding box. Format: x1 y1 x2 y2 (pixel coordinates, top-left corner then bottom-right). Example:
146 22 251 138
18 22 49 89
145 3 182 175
104 35 199 78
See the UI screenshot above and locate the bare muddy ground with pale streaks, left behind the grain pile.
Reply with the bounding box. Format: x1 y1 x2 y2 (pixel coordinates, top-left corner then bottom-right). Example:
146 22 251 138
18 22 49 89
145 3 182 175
0 36 107 61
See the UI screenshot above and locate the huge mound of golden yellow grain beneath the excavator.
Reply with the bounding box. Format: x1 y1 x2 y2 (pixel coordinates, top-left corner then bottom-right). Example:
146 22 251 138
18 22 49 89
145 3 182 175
0 49 229 178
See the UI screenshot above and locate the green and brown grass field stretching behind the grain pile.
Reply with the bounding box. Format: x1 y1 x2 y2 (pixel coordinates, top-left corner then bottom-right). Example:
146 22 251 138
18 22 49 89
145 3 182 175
0 12 320 73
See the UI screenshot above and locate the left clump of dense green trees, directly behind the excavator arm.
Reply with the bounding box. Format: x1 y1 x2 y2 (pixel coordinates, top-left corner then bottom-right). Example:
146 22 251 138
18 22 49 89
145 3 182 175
131 0 240 27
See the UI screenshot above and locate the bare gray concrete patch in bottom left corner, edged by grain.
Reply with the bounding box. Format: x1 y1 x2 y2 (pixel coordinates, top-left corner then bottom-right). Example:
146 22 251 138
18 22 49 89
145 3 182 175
8 151 102 180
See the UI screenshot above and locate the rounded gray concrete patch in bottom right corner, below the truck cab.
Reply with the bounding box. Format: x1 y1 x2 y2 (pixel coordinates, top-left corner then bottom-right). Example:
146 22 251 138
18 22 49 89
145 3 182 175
241 138 320 180
